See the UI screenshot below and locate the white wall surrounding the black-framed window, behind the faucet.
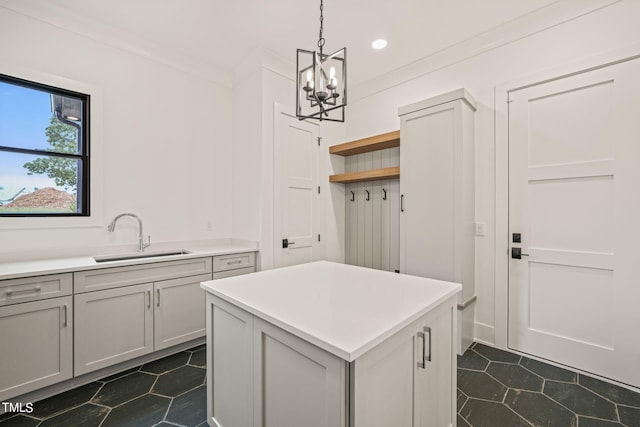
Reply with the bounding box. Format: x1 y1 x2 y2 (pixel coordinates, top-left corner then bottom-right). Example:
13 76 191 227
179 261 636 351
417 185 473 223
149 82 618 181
0 6 233 261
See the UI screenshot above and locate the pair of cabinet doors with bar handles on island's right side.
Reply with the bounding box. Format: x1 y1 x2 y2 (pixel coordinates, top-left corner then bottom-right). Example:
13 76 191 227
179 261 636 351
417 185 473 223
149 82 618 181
352 297 456 427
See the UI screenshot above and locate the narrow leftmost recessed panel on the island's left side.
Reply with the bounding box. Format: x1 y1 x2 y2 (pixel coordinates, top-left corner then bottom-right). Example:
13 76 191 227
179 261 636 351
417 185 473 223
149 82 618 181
207 294 253 426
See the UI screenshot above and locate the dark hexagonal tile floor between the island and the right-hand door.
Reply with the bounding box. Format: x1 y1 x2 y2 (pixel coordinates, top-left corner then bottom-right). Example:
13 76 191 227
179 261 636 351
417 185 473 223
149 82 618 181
458 343 640 427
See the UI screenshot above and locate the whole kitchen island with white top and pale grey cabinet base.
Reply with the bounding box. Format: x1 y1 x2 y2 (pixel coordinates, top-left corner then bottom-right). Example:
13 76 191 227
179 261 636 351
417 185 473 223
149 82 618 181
202 261 461 427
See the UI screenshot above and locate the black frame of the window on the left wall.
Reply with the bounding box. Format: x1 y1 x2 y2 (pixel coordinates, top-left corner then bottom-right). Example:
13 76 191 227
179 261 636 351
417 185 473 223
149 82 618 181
0 73 91 218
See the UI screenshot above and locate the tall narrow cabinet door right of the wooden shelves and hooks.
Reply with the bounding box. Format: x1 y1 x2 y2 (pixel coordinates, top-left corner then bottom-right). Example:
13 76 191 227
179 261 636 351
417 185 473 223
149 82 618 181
400 103 459 280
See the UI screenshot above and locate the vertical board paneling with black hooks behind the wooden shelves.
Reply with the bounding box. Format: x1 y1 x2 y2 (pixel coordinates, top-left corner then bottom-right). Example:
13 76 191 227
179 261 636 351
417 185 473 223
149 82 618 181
345 147 400 271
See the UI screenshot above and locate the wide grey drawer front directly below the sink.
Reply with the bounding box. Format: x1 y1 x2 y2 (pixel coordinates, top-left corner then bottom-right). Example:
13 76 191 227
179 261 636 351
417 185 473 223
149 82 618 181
73 257 211 294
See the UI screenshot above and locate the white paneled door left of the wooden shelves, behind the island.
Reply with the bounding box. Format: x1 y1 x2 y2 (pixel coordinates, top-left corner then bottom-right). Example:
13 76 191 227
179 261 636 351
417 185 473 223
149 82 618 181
273 104 319 267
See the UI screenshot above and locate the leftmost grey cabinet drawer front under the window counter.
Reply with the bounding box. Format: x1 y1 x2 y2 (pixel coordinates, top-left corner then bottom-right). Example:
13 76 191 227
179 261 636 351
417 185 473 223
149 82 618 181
0 273 73 306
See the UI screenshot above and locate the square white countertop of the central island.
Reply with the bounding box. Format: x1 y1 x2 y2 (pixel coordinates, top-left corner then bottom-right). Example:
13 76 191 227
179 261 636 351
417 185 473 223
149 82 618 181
202 261 462 362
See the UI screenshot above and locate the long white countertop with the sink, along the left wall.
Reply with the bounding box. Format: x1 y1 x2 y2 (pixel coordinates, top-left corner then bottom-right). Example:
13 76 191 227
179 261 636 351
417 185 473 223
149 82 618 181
0 239 258 280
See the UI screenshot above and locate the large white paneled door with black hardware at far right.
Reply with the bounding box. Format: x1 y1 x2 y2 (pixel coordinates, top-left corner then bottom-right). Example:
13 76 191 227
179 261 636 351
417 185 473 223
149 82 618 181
509 60 640 386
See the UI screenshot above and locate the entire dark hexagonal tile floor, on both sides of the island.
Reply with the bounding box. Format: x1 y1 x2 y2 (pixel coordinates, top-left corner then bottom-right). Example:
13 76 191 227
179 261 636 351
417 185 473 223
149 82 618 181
0 343 640 427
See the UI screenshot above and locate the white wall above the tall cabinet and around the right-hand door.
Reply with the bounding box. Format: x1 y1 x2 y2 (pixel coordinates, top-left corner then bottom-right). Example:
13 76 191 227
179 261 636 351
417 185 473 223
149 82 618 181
347 0 640 345
